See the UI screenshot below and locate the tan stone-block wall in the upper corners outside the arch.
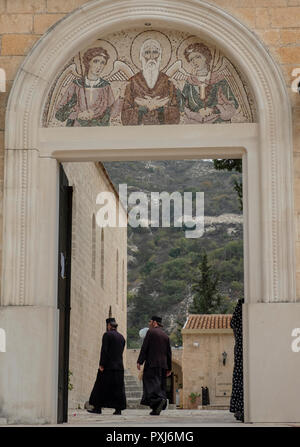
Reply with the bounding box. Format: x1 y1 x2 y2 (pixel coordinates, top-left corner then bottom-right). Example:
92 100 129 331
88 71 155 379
0 0 300 298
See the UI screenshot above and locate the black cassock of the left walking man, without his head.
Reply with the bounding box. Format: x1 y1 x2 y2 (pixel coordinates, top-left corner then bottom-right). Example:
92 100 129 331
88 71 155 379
89 330 126 410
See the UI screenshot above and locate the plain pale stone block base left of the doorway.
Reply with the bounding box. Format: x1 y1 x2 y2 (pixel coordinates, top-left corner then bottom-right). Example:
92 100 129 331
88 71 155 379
0 306 59 424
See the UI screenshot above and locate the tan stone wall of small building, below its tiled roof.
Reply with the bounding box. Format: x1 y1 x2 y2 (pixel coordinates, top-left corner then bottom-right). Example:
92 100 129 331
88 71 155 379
182 329 234 408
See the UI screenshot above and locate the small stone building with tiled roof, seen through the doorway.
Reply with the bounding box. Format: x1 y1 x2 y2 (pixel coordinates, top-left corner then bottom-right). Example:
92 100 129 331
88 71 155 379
182 314 234 408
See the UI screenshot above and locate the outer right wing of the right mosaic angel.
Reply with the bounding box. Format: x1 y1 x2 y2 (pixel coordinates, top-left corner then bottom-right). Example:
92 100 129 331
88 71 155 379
212 57 253 122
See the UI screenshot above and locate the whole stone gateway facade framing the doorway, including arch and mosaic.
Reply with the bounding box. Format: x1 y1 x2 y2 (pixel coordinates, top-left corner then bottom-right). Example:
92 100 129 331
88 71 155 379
0 0 300 423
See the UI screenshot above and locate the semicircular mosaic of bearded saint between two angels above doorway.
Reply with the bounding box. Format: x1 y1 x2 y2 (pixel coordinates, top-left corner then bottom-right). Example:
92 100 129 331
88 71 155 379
43 30 256 127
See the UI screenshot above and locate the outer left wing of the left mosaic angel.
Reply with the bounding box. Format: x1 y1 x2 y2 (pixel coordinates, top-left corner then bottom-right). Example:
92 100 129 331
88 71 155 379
45 62 81 127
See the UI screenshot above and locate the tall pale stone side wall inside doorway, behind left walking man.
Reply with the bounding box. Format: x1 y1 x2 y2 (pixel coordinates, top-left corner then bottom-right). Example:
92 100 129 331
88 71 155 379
63 162 127 408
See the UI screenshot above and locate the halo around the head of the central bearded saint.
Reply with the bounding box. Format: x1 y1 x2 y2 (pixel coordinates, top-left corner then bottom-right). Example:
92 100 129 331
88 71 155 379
130 30 172 70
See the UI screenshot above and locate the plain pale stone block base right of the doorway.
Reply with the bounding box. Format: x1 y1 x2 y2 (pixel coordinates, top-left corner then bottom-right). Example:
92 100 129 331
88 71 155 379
243 303 300 422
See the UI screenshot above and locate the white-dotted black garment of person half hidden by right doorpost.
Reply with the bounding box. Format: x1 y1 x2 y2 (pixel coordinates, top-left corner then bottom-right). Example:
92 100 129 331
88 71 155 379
230 300 244 418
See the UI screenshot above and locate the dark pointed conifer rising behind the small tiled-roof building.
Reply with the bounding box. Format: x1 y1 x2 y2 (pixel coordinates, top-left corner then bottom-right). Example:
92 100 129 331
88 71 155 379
189 250 221 314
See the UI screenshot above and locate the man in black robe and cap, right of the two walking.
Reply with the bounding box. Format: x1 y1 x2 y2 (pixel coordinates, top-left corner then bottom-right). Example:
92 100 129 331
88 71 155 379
137 316 172 416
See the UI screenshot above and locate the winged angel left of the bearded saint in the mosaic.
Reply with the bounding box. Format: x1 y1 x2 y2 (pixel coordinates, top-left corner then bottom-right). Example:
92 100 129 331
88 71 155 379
48 47 133 127
